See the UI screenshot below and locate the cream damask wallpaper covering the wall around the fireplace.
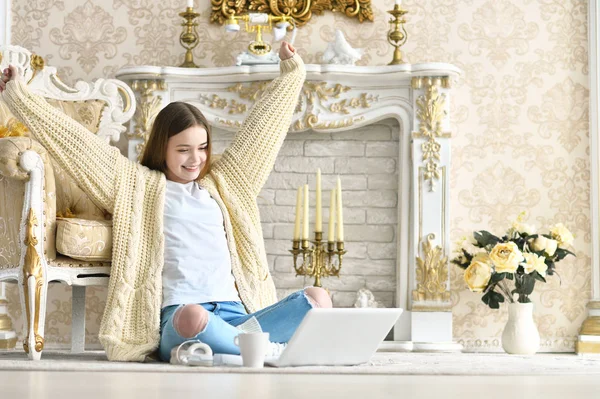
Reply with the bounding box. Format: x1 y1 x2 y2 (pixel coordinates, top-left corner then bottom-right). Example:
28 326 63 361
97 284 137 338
9 0 591 351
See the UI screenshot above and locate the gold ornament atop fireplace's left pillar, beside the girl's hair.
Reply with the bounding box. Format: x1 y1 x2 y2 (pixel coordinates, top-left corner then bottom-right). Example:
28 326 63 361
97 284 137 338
129 79 166 160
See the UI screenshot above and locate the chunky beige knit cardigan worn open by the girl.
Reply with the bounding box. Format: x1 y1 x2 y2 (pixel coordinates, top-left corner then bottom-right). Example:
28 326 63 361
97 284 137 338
3 54 306 361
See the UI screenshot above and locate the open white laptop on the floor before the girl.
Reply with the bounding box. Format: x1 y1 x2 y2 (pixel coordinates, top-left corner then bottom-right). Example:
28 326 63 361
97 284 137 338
265 308 402 367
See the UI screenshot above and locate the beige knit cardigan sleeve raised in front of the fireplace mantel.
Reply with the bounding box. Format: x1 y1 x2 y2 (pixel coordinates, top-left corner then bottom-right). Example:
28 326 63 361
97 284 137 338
219 54 306 195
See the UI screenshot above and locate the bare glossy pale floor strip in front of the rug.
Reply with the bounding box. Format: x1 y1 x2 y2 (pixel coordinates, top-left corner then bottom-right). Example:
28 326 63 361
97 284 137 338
0 371 600 399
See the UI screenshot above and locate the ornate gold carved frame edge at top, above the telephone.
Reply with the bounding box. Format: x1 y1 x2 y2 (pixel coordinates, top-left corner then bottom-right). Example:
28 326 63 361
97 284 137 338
210 0 373 26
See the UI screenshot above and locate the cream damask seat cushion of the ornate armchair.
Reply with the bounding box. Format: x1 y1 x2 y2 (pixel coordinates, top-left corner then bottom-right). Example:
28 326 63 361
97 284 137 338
56 218 112 261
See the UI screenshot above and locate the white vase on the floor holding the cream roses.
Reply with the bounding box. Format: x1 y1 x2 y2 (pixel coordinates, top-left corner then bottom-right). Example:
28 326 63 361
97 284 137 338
502 303 540 355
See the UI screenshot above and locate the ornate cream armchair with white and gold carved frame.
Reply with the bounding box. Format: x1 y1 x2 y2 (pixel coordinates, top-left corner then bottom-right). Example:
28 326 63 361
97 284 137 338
0 46 135 360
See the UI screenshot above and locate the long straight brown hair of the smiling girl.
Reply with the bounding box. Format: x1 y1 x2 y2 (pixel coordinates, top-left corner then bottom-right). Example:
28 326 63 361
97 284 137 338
140 101 212 180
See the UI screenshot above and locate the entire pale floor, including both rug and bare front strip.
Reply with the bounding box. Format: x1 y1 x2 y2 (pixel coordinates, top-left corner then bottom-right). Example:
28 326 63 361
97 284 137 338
0 350 600 399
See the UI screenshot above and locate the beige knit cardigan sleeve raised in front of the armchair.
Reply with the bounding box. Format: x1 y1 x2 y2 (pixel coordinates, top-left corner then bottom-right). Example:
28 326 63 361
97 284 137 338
3 80 125 213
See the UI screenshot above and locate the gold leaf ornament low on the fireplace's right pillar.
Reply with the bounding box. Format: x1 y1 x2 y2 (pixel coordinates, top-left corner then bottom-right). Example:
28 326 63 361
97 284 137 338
412 234 451 312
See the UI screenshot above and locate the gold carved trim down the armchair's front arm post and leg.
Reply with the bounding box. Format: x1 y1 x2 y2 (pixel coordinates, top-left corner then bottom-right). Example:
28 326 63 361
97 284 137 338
23 208 44 353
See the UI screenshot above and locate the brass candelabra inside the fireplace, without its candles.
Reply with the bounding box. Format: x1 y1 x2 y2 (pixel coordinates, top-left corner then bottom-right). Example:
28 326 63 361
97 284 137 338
290 231 346 287
